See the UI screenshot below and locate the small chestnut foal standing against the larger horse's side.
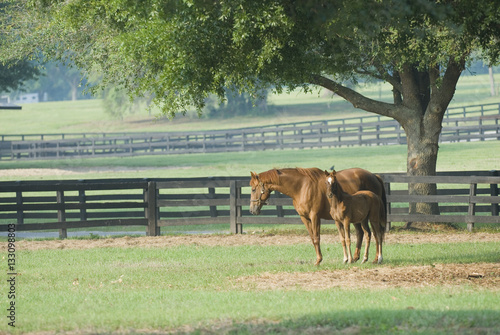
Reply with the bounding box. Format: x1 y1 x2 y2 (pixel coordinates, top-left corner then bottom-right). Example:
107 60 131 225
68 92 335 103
325 170 386 264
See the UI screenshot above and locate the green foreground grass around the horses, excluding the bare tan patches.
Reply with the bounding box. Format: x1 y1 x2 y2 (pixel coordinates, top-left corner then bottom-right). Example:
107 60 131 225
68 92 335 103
0 243 500 334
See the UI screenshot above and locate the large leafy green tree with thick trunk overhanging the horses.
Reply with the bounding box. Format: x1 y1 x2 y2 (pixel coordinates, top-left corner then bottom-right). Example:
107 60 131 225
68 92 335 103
3 0 500 218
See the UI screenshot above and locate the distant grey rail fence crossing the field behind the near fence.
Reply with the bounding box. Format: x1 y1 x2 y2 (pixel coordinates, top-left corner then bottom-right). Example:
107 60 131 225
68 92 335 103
0 103 500 160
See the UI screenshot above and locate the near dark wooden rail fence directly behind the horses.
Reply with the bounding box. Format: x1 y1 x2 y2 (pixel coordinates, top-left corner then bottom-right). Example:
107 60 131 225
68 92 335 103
0 171 500 238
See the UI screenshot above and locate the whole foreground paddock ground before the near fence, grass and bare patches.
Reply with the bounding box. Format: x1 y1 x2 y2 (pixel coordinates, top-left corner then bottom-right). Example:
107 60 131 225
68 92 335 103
4 233 500 334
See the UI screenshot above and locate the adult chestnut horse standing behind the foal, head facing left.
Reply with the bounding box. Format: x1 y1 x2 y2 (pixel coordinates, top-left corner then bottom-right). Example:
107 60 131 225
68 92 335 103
250 168 386 265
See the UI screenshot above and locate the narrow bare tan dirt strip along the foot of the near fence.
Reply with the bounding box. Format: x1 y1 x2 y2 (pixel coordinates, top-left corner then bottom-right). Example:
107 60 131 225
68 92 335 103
9 233 500 250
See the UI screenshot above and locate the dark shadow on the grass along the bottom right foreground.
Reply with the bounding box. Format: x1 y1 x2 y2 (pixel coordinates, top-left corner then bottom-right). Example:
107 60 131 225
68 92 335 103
173 306 500 334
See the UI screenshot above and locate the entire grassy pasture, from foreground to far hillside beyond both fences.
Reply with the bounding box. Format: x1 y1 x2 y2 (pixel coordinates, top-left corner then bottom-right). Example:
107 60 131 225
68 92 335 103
0 76 500 335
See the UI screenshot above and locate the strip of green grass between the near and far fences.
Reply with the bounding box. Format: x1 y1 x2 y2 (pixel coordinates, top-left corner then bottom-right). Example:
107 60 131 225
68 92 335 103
0 141 500 181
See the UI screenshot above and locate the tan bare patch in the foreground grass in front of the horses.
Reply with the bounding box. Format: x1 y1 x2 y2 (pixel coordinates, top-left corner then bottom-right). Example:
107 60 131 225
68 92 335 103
235 263 500 291
